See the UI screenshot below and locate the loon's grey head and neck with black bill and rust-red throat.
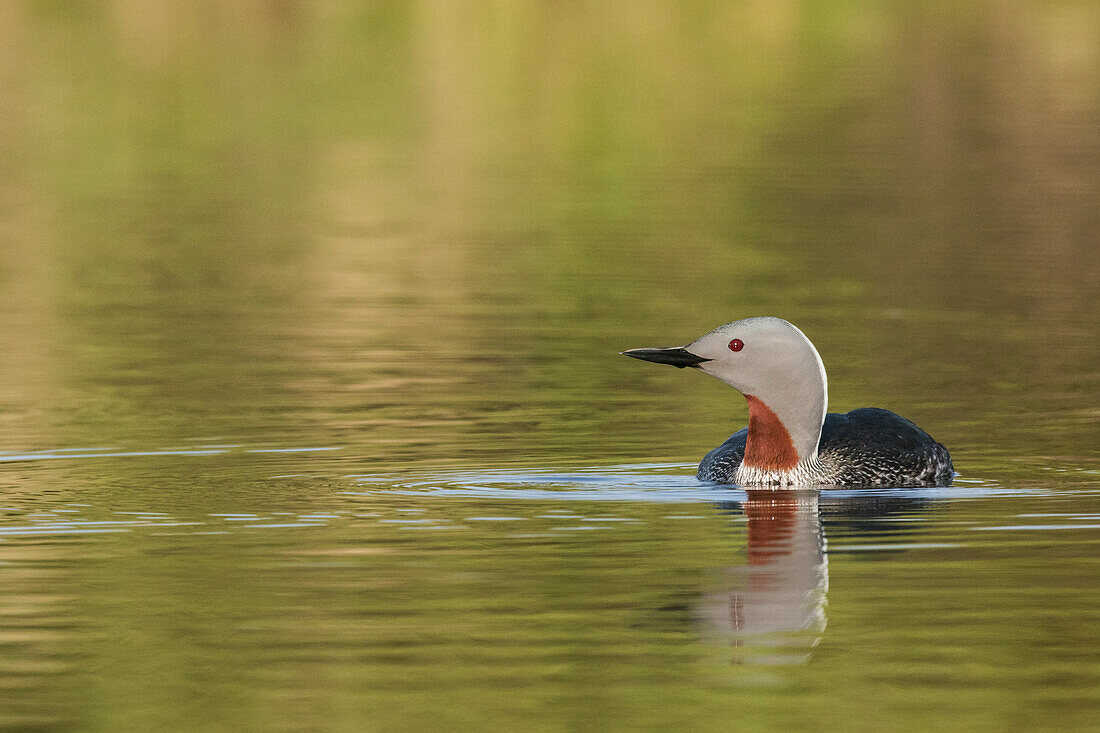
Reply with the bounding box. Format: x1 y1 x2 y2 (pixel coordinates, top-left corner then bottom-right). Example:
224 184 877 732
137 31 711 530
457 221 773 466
623 316 828 478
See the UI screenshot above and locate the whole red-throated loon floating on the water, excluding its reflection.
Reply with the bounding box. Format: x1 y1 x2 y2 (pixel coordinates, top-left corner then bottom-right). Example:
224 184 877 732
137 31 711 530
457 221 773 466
623 317 955 488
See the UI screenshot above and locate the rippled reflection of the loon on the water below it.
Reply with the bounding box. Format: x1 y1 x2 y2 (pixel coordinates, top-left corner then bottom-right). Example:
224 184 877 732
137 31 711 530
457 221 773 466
699 490 928 665
